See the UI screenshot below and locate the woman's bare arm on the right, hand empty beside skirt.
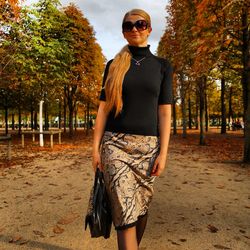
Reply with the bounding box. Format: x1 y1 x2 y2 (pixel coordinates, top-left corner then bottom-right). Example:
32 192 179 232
151 104 171 176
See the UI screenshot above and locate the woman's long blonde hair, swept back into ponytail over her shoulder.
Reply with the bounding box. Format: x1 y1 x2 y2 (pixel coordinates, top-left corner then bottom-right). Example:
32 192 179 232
105 9 151 117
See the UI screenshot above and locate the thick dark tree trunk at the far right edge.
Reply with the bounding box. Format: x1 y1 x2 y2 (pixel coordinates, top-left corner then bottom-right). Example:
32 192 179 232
241 3 250 163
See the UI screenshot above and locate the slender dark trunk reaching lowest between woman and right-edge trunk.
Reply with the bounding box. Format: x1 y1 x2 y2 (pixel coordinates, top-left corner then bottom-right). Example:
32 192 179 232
199 76 206 145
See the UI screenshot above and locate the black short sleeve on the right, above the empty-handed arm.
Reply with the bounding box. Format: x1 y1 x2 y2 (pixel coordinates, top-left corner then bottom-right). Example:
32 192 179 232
158 60 173 105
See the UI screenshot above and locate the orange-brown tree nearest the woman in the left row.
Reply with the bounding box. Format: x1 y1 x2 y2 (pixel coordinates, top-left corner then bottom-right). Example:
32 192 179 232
64 4 104 136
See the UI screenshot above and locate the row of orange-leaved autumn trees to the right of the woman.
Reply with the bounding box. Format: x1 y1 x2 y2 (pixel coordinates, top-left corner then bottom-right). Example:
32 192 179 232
158 0 250 162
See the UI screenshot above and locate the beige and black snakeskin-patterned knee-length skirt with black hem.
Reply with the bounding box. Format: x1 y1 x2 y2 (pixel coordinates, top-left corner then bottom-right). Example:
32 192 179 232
101 131 159 229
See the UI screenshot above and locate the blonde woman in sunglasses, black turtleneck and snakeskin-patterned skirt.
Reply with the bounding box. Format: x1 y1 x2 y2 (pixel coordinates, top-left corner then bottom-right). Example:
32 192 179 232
93 9 172 250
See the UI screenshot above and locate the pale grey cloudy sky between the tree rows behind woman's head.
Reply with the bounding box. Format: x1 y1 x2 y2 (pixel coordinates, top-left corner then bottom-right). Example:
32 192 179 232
25 0 168 60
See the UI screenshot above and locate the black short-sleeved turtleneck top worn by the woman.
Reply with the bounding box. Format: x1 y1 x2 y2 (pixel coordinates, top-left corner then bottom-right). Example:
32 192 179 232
100 46 172 136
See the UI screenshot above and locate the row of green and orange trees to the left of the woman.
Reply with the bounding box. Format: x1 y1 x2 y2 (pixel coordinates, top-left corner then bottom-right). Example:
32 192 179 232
0 0 105 135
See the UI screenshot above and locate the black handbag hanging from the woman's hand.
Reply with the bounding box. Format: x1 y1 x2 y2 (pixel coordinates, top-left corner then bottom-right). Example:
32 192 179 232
85 168 112 239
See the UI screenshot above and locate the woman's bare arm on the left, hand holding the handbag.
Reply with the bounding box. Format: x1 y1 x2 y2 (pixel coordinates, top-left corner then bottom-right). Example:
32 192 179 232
92 101 107 171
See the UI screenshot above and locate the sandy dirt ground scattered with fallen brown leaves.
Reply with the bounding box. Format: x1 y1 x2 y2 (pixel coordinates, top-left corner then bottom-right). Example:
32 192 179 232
0 131 250 250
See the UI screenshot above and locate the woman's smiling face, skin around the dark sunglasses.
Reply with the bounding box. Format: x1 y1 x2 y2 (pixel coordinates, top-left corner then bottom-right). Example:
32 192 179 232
123 15 152 47
